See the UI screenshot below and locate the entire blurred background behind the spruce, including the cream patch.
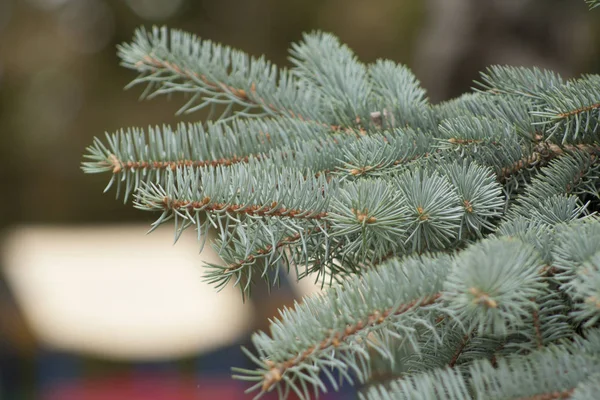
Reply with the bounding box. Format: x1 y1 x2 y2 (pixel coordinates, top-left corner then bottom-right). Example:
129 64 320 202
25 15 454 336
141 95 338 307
0 0 600 400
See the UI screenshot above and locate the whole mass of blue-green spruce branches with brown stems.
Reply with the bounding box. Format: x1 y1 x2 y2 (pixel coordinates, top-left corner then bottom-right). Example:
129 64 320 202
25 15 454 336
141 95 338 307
82 21 600 399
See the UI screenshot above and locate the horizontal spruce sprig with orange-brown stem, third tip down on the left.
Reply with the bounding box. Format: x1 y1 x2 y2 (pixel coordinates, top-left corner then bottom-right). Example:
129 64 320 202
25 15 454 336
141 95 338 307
134 163 337 245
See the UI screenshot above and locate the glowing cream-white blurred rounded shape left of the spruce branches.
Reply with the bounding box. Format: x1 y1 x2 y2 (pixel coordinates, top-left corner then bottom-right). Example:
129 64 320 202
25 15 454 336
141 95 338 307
1 225 253 360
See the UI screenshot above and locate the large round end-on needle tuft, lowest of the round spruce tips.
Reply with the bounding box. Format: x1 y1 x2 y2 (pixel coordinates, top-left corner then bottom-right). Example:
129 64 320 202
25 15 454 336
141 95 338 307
443 239 544 336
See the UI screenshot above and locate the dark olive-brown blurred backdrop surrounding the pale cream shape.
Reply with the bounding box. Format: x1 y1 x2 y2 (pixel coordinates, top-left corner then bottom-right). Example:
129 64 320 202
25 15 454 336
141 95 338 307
0 0 600 400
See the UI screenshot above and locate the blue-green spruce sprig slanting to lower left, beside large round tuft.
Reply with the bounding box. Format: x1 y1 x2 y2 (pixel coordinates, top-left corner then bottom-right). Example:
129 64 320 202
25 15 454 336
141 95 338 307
237 257 448 398
